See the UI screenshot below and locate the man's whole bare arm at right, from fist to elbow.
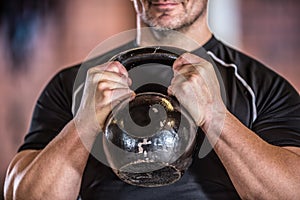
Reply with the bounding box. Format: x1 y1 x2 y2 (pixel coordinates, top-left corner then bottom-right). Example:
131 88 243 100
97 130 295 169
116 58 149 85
168 54 300 199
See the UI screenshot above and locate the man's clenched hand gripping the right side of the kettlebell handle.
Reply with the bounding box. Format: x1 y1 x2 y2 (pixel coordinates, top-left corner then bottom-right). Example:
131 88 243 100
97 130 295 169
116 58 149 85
168 53 226 131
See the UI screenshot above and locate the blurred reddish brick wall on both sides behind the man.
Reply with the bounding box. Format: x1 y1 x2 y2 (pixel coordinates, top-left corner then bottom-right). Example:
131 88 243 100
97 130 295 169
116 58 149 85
0 0 300 199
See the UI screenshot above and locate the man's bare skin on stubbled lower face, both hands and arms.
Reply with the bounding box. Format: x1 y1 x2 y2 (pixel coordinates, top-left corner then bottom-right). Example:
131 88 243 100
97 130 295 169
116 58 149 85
5 0 300 200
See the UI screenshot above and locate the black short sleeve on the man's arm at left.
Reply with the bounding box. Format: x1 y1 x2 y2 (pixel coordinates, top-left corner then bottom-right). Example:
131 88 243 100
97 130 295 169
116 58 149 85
19 69 75 151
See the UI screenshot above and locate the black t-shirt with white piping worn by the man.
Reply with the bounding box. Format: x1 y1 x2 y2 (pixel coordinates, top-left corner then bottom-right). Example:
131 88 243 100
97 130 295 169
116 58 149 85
19 37 300 200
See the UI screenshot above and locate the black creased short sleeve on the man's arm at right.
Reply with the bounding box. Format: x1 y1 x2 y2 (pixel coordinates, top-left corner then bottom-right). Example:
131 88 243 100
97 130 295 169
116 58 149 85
252 70 300 147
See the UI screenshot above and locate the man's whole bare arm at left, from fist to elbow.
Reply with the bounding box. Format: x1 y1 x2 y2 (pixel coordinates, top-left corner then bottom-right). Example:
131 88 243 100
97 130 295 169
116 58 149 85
4 62 135 200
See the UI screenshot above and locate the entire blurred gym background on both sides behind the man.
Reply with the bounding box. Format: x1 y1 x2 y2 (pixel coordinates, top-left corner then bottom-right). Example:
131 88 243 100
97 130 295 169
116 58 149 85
0 0 300 199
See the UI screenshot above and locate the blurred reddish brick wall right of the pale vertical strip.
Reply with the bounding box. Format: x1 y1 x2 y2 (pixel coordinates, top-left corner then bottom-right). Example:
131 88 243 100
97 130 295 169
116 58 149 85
241 0 300 91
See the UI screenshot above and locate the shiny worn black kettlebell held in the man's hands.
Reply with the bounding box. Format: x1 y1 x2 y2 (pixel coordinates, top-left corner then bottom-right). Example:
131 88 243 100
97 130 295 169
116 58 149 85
103 47 197 187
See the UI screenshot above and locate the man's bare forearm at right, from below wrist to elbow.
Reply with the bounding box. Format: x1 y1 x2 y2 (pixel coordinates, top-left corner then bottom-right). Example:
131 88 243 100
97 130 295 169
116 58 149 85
209 113 300 199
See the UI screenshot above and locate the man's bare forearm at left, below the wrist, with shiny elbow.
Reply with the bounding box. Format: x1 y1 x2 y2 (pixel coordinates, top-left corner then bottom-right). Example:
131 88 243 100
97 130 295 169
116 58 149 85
6 121 92 200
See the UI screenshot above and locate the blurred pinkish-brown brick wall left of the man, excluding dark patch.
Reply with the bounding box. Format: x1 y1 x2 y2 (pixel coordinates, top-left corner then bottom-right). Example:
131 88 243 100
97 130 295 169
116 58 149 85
0 0 135 199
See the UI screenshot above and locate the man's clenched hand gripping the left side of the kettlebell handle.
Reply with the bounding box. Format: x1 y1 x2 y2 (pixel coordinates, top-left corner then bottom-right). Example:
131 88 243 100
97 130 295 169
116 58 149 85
74 62 135 138
